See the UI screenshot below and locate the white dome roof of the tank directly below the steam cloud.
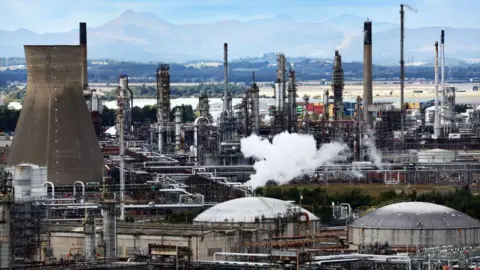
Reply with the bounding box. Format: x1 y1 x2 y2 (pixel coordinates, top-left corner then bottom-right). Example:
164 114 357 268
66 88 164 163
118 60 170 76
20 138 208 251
193 197 319 223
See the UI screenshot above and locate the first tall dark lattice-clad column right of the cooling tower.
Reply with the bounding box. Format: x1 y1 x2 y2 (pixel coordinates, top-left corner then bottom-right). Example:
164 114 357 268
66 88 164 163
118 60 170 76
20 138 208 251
157 64 170 153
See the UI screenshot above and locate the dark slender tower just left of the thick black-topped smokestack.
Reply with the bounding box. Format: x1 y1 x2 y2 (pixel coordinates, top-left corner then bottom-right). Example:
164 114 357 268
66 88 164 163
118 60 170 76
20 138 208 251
332 50 343 121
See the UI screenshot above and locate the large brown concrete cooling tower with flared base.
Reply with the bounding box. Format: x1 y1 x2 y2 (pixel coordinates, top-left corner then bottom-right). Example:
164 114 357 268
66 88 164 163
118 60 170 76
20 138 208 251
8 46 103 185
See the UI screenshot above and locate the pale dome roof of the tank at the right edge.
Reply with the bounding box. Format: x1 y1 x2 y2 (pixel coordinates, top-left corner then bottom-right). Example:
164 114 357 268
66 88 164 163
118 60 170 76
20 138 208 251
350 202 480 229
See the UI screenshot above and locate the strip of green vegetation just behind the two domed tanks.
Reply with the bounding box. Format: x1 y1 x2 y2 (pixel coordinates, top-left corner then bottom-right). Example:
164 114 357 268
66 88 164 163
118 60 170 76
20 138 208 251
289 184 455 197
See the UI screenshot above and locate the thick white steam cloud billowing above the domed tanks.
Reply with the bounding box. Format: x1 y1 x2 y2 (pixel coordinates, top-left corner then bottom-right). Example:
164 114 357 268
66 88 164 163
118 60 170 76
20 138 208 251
240 132 350 188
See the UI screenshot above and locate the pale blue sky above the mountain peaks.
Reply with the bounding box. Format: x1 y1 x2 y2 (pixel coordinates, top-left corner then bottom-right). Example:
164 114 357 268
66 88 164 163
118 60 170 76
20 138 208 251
0 0 474 33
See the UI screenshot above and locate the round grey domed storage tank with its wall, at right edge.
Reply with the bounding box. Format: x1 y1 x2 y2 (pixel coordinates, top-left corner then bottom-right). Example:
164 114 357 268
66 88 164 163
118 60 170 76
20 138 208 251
348 202 480 247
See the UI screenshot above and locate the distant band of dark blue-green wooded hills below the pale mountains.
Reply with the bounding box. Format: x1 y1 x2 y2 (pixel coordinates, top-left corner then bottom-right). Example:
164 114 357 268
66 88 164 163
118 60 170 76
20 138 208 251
0 59 480 86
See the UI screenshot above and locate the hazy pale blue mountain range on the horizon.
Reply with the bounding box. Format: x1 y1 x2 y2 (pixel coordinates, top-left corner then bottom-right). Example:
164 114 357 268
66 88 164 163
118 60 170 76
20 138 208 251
0 10 480 65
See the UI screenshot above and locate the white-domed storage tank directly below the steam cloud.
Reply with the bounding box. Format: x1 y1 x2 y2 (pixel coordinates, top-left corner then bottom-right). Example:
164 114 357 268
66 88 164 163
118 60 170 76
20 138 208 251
193 197 320 236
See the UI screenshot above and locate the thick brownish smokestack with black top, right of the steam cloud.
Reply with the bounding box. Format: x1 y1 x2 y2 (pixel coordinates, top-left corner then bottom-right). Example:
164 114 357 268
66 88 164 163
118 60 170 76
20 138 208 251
363 21 373 128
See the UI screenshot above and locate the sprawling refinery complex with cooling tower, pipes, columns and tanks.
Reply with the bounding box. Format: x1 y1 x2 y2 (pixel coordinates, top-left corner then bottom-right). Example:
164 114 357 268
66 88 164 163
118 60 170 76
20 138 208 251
0 5 480 269
